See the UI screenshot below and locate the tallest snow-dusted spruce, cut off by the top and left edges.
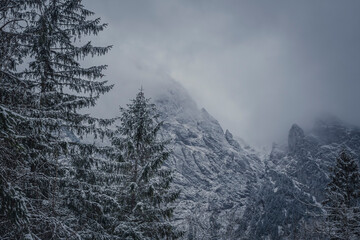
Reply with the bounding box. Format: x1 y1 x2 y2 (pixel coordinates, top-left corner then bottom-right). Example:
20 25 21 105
0 0 119 239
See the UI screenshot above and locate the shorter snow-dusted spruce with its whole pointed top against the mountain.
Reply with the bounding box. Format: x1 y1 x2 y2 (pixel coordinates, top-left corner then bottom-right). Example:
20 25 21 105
112 90 180 239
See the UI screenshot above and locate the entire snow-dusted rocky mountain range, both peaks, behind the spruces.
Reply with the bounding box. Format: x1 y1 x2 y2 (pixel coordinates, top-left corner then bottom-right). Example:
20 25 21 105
153 79 360 240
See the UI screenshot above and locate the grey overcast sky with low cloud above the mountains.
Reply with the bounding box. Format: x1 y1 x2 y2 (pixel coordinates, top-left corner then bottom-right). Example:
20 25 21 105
83 0 360 144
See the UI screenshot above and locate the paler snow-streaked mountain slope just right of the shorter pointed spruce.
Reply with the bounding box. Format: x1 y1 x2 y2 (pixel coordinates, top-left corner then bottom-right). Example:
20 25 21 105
153 82 264 239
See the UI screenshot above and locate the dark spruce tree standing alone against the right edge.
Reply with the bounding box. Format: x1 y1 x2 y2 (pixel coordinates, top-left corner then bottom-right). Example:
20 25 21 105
323 151 360 240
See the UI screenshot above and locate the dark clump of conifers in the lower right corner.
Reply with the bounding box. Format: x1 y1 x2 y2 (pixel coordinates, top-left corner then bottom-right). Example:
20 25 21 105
298 150 360 240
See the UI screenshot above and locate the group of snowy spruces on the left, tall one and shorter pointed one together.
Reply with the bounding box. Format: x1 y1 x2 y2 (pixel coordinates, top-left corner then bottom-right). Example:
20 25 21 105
0 0 178 239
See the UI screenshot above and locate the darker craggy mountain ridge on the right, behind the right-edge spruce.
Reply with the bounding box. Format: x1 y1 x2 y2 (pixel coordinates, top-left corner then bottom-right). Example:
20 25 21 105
237 117 360 239
